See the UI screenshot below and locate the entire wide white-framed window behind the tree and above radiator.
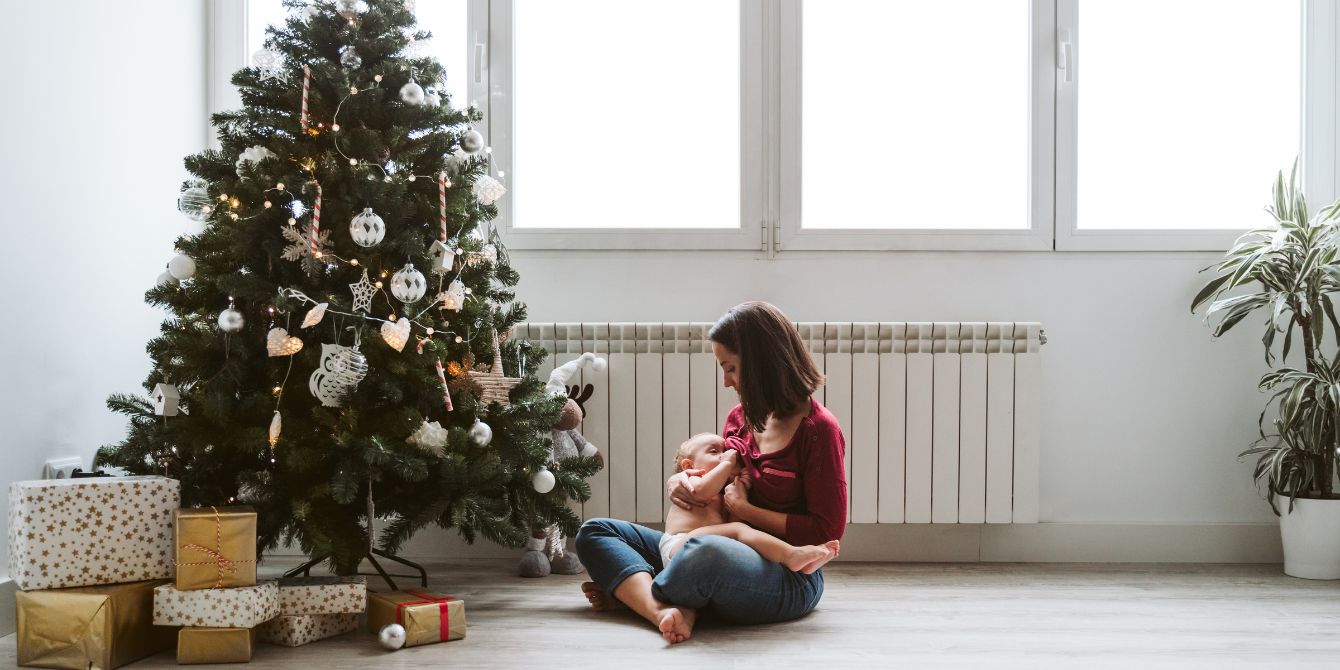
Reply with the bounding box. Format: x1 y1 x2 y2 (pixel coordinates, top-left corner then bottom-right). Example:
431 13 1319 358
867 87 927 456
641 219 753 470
210 0 1340 253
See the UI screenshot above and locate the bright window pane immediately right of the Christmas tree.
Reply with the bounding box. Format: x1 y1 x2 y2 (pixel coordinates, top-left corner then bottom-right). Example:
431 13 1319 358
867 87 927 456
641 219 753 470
514 0 741 229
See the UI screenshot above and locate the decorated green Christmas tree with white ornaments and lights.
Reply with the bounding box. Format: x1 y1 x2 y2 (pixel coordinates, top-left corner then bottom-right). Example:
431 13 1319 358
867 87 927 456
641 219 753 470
96 0 599 574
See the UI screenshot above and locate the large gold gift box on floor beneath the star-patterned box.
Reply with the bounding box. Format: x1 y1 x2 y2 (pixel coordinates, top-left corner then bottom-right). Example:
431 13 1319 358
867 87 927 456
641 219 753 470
15 579 176 670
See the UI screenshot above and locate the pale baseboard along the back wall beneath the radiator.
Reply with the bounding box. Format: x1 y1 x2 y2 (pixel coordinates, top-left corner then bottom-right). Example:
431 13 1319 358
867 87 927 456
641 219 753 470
272 523 1284 563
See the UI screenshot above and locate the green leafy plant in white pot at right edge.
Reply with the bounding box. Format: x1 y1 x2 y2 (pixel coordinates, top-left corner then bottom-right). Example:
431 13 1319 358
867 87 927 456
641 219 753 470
1191 163 1340 579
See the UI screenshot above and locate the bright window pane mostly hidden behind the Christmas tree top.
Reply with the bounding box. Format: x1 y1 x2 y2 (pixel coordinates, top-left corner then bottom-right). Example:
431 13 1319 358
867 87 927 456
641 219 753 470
247 0 470 107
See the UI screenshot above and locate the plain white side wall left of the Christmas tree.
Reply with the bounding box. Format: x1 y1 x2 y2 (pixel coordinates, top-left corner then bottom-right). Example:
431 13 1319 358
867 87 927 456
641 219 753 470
0 0 208 581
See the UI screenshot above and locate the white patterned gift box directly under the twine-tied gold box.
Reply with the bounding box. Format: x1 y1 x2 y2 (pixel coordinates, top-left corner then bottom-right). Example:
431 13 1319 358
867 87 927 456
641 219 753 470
154 580 279 628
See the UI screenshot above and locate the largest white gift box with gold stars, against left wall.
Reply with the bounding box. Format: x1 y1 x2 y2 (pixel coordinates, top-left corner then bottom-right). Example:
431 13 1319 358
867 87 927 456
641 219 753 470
8 477 181 591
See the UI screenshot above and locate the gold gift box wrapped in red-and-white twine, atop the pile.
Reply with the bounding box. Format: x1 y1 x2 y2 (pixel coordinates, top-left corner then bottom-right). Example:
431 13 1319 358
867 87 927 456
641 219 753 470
176 507 256 591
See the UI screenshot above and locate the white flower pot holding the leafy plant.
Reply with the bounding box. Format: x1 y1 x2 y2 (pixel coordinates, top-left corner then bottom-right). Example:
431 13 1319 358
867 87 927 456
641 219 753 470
1276 496 1340 579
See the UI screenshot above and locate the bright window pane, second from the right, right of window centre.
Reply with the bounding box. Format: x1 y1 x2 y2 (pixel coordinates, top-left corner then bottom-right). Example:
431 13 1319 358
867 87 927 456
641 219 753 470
801 0 1030 229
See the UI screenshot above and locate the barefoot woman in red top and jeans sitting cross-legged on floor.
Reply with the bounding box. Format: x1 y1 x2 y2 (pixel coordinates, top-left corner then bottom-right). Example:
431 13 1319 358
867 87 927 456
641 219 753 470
576 303 847 643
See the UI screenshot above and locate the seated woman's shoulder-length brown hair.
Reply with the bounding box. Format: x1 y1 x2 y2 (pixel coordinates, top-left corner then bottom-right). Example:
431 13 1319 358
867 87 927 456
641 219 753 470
708 302 824 433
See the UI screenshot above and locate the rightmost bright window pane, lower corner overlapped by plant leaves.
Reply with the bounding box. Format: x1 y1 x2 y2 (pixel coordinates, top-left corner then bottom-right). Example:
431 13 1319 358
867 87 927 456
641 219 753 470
1076 0 1301 229
